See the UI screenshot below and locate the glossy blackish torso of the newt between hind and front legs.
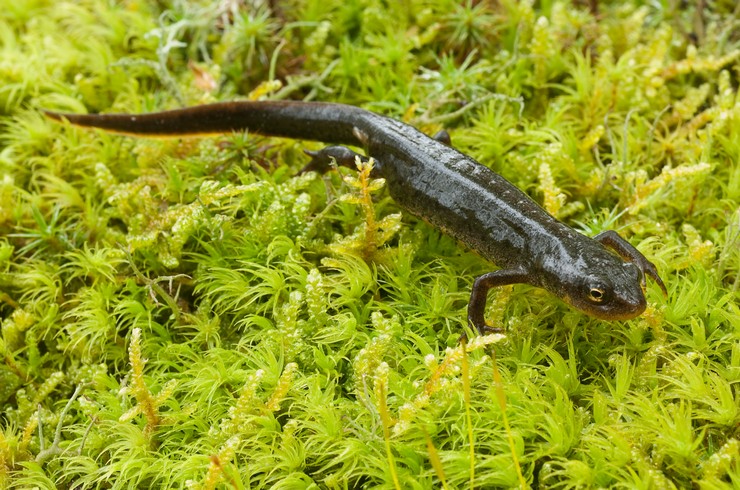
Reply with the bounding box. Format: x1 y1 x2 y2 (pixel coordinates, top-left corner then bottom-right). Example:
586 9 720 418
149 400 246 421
368 120 576 267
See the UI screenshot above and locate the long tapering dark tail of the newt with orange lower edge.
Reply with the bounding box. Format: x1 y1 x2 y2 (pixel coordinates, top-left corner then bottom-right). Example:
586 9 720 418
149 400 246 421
44 101 368 145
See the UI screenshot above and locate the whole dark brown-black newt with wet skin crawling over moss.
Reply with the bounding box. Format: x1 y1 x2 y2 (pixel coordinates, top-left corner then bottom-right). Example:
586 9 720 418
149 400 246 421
47 101 665 332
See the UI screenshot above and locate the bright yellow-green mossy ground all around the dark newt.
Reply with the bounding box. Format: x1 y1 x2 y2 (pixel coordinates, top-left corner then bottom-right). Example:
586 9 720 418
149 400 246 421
0 0 740 489
